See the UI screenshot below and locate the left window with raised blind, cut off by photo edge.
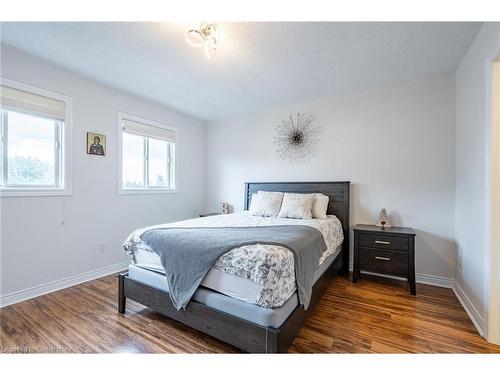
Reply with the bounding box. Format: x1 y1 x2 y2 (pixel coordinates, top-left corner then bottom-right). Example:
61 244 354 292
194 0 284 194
0 79 71 196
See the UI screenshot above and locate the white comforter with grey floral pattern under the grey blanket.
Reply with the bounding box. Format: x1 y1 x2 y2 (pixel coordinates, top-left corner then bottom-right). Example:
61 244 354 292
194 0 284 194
124 211 344 307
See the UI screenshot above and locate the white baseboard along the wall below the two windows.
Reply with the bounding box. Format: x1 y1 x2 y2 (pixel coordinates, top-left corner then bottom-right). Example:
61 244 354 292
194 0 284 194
0 261 130 307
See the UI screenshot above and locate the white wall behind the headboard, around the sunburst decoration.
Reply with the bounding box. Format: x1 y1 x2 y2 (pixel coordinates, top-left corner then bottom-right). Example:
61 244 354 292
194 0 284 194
206 76 456 278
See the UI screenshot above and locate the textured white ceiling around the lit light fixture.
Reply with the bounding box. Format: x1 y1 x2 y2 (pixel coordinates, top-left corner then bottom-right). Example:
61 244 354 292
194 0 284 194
1 22 482 120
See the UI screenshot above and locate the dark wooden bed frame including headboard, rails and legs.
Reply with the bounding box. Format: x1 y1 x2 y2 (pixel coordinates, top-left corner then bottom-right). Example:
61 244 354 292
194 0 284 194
118 181 349 353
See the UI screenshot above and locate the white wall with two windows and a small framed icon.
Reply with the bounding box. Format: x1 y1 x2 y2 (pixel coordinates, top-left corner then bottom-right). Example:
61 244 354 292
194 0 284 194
0 46 205 302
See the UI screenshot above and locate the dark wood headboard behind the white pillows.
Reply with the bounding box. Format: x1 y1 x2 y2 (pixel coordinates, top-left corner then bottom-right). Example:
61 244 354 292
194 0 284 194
245 181 350 267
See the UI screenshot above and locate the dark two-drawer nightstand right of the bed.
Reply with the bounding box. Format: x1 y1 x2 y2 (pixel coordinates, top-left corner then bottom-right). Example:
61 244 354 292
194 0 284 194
352 224 417 295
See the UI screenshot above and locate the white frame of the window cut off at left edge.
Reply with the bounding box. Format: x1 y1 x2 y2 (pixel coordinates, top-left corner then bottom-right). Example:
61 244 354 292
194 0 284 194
0 77 73 197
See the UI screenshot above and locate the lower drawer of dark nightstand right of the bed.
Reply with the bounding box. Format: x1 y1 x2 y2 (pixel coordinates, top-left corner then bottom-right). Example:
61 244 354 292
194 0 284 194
359 248 408 276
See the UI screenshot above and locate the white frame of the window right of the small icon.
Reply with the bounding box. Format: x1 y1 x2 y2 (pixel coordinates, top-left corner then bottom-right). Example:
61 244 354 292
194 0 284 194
117 112 179 195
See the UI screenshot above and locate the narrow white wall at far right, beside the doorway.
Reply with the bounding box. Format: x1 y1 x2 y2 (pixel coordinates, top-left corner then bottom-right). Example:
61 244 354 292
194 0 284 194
455 23 500 340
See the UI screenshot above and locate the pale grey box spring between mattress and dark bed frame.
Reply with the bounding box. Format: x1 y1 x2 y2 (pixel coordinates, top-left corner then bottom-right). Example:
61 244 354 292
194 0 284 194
128 246 341 328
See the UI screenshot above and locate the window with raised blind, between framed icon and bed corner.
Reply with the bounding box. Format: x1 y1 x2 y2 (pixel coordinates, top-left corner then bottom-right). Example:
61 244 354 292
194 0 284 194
118 113 177 194
